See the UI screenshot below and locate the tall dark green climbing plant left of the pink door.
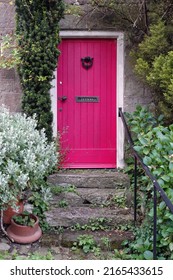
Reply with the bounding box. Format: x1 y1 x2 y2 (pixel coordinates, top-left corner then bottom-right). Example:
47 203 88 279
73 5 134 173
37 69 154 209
15 0 64 140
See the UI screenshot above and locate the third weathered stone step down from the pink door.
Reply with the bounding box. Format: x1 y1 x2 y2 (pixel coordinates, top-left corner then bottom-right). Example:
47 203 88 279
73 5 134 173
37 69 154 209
45 207 133 228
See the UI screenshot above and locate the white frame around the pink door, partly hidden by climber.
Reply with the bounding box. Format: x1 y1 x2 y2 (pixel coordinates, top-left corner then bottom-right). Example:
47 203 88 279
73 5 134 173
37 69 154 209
50 30 124 168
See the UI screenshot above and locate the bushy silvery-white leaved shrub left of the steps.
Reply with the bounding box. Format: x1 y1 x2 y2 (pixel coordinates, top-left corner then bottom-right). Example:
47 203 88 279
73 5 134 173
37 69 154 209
0 107 58 209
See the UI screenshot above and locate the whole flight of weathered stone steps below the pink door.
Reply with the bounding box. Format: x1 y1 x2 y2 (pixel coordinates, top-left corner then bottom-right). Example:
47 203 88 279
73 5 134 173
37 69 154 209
45 170 133 248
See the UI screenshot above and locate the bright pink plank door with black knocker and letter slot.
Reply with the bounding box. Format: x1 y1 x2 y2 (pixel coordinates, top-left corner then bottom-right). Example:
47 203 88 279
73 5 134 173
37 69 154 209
57 39 116 168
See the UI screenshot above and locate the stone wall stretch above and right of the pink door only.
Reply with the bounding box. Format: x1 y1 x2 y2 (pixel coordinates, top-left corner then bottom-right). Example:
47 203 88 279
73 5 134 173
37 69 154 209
61 0 152 112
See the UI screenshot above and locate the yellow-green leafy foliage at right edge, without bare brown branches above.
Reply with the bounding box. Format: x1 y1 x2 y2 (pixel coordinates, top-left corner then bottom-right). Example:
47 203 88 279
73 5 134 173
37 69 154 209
131 20 173 123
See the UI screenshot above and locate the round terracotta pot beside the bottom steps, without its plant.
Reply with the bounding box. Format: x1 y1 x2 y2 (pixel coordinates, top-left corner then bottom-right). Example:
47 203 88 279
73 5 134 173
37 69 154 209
7 214 42 244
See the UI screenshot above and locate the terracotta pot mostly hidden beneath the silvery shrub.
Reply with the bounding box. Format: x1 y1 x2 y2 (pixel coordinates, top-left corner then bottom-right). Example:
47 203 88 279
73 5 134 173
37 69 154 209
3 200 24 225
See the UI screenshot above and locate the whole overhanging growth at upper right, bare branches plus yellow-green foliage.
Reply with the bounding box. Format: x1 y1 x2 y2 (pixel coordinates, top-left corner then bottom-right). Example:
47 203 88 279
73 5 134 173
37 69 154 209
90 0 173 124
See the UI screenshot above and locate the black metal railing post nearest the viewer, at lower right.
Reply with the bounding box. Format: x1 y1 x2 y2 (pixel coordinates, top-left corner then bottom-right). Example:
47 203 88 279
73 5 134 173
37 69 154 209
153 185 157 260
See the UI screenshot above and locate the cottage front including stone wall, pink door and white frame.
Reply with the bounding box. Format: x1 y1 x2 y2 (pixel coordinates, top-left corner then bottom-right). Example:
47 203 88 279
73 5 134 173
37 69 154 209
0 0 152 168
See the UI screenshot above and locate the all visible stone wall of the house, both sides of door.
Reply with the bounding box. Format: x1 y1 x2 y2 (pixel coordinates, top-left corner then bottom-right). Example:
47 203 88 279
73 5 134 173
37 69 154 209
0 0 152 112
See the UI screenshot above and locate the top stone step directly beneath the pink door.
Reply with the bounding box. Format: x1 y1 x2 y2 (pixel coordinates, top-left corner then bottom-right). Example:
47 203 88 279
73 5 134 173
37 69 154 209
48 170 130 189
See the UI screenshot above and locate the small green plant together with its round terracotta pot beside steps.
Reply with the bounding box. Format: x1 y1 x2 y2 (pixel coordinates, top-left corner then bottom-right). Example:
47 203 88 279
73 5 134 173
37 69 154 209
7 211 42 244
